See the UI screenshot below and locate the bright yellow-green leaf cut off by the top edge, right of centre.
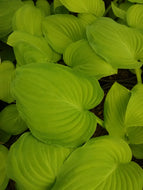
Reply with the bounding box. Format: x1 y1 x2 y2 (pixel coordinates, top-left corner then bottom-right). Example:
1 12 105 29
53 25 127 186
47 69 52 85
60 0 105 16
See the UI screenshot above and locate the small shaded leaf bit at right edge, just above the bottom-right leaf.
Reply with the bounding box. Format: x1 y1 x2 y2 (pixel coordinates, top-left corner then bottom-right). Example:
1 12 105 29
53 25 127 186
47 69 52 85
130 144 143 159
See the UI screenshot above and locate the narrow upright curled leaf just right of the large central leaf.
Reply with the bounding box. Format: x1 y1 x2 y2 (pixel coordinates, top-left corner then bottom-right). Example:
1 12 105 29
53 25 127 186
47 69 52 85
104 83 131 137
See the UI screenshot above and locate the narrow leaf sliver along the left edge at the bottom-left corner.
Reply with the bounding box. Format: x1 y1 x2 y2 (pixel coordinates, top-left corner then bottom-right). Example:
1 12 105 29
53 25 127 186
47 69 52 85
0 144 9 190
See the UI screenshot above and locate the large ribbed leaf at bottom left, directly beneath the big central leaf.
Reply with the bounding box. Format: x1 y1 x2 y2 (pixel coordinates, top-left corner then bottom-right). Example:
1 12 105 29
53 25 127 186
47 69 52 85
7 132 73 190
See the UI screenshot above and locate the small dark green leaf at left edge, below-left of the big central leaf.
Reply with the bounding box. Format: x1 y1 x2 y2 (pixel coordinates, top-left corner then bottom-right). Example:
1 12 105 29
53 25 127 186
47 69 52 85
0 104 27 135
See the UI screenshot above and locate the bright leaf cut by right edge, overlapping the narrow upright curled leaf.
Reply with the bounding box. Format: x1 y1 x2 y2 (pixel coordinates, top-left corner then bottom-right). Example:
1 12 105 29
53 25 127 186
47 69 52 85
125 84 143 127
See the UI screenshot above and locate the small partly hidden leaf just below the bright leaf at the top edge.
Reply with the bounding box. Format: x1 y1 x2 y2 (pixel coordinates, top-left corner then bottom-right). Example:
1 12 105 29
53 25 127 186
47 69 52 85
78 13 97 27
